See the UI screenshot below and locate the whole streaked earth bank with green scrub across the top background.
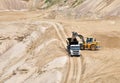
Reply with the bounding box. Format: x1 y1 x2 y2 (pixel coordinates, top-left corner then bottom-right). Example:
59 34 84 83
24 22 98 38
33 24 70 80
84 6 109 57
0 0 120 18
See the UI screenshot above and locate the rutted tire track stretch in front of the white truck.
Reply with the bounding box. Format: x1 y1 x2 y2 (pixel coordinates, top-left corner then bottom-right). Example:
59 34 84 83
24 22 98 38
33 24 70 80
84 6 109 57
64 57 81 83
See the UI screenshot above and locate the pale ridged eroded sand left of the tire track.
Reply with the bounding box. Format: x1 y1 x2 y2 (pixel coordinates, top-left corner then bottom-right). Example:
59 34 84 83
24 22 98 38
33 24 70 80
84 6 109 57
0 18 67 83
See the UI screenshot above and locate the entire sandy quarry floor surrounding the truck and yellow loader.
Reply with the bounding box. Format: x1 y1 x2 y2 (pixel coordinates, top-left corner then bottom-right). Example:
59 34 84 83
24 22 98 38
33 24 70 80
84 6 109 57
0 12 120 83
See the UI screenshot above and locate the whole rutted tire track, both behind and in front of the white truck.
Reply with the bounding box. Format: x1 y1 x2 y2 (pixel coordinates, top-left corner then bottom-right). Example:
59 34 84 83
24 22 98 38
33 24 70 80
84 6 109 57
30 21 81 83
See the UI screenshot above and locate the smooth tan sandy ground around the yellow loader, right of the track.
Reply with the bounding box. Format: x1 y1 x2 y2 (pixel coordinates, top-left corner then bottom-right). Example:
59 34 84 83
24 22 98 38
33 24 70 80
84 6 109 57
62 20 120 83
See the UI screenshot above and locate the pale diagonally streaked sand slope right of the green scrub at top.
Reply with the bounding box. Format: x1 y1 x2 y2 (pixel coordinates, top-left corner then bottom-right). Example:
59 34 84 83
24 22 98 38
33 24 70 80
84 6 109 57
75 0 120 16
